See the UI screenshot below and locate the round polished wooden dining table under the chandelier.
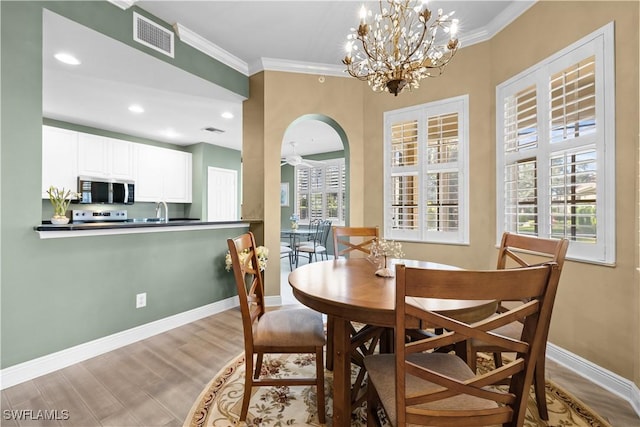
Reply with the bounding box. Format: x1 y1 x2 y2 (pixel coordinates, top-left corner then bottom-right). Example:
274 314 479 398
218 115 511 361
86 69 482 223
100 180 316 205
289 258 497 426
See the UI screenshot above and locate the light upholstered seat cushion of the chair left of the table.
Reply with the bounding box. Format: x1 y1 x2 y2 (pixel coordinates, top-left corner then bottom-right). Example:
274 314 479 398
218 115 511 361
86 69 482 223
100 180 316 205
253 308 325 347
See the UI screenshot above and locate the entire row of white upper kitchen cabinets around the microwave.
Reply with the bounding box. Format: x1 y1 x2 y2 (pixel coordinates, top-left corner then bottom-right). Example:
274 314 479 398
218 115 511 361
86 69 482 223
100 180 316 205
42 126 192 203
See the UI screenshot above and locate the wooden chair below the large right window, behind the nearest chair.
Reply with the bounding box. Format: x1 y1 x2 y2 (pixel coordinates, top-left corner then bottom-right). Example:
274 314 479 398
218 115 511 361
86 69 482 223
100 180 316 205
465 233 569 420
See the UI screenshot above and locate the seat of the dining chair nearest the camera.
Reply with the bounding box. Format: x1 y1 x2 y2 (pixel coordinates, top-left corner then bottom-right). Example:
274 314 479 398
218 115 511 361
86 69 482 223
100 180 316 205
364 353 498 425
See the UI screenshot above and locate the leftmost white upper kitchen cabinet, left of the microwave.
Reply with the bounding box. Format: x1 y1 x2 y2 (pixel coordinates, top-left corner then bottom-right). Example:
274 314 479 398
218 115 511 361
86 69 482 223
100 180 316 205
42 126 78 199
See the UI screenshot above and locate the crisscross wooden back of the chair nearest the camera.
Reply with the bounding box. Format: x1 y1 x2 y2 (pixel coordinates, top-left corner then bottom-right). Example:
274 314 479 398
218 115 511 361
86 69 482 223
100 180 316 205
395 262 559 426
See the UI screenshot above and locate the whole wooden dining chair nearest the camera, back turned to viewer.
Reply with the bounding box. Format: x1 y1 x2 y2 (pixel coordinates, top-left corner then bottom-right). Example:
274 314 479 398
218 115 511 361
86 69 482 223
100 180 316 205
365 263 559 427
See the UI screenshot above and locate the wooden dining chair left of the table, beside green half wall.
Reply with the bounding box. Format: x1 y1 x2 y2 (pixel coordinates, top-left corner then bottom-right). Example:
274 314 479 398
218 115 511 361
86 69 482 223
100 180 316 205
227 232 325 423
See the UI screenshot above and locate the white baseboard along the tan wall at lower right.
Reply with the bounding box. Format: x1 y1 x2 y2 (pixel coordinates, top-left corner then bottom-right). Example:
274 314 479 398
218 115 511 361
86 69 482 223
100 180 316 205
547 343 640 417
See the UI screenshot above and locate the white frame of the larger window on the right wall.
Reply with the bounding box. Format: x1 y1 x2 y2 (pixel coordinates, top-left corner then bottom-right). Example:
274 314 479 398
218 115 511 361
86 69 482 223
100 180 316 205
496 22 616 265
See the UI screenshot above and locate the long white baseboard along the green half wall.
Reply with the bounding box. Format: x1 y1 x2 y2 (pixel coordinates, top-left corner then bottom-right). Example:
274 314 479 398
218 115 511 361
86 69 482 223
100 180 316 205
0 296 239 390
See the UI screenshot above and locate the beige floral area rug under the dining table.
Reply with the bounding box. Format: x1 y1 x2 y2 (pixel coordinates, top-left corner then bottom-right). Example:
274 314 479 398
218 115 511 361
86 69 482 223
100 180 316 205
184 353 611 427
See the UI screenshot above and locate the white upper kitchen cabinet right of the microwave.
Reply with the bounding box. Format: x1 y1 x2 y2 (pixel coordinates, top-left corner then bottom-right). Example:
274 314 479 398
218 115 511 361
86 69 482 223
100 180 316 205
135 144 192 203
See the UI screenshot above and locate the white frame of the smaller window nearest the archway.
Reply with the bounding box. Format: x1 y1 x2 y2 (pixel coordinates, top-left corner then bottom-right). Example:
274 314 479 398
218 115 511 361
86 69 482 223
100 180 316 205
383 95 469 245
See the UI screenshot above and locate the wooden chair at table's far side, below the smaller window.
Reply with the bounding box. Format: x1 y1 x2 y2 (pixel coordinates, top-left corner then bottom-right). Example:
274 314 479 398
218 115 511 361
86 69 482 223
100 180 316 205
326 226 384 380
